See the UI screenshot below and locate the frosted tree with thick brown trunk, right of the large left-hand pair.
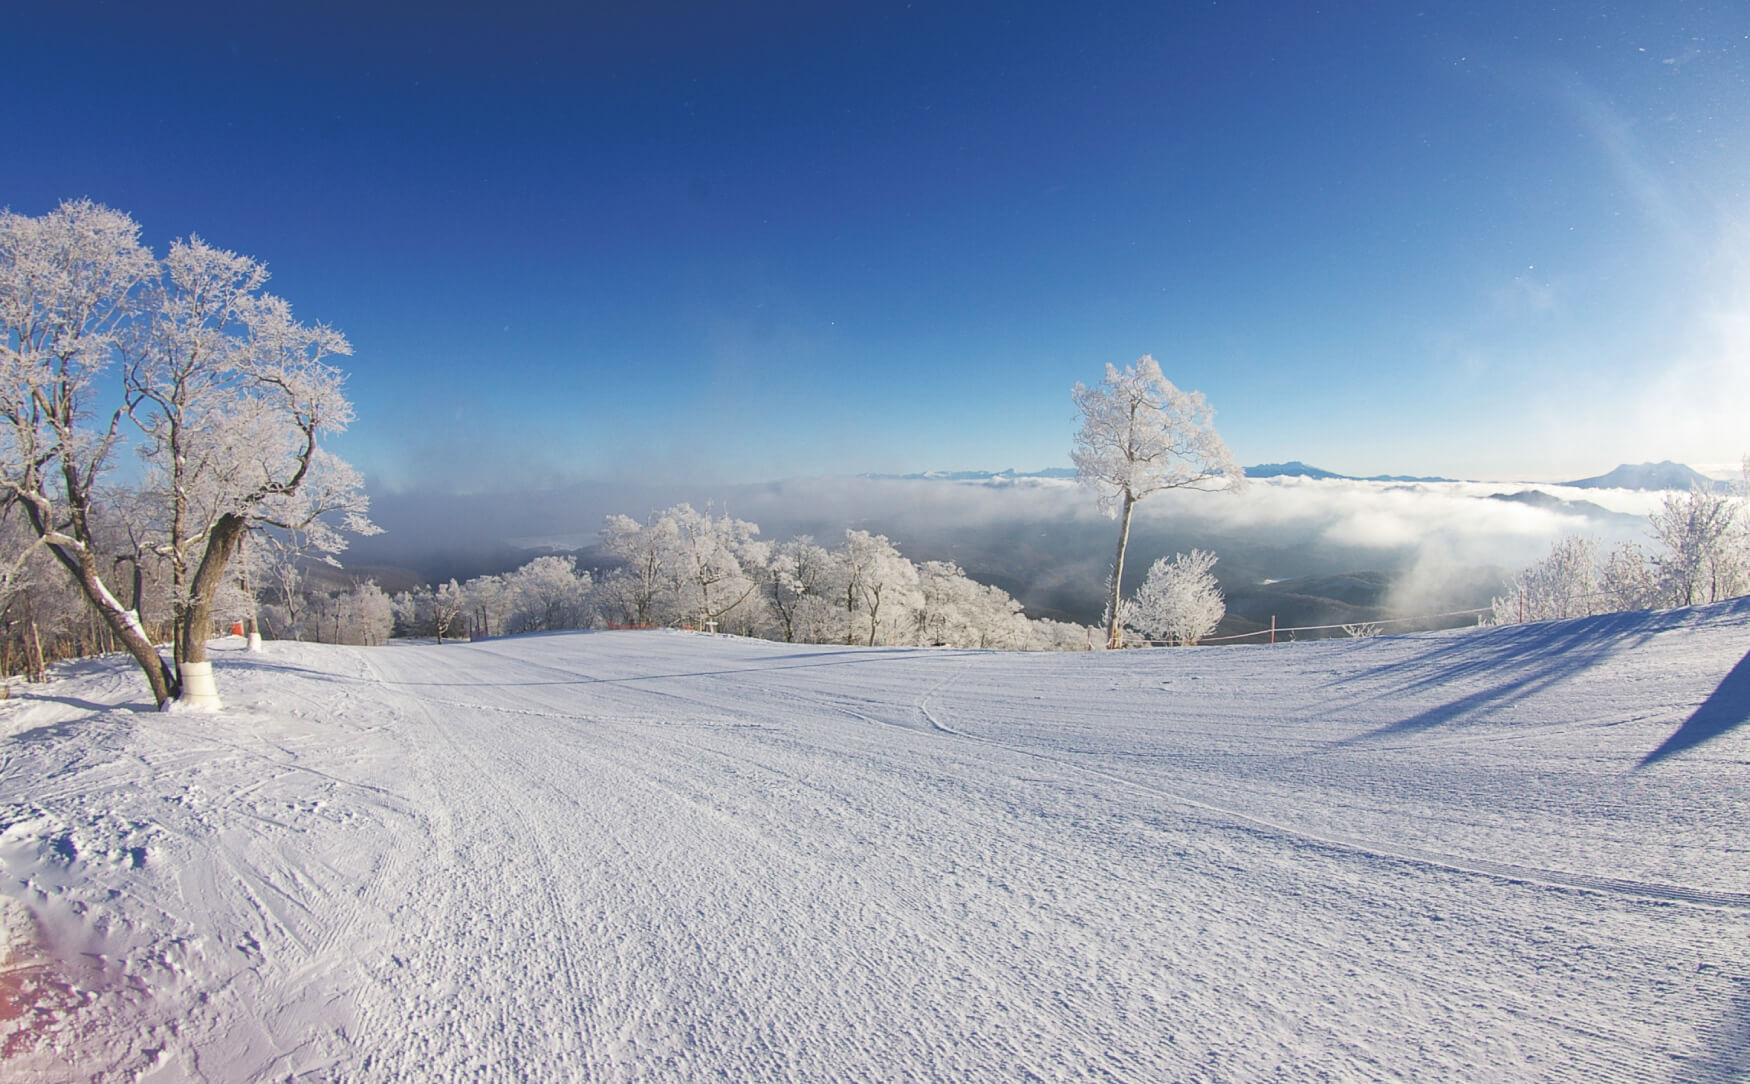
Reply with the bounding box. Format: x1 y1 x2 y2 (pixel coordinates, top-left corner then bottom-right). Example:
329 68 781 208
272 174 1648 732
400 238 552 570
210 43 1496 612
123 238 375 686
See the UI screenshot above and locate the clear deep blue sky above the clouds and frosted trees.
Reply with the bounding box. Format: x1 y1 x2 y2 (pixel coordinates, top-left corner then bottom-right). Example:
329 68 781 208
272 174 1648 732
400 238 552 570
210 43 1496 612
0 0 1750 492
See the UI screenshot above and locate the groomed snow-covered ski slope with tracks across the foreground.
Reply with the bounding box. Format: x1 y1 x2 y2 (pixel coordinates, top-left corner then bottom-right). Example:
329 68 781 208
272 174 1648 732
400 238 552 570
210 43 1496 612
0 601 1750 1080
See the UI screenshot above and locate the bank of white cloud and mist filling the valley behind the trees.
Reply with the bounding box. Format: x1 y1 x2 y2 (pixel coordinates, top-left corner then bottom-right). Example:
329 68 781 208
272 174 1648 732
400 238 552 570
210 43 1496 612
348 476 1661 613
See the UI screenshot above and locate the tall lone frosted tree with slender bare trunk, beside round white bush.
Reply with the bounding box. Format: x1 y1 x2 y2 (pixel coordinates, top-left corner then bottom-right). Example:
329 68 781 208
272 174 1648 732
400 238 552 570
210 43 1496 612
1071 354 1246 648
